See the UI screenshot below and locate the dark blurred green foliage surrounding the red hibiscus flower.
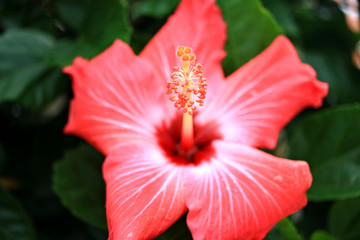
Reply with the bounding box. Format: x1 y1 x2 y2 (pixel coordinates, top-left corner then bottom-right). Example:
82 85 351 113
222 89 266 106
0 0 360 240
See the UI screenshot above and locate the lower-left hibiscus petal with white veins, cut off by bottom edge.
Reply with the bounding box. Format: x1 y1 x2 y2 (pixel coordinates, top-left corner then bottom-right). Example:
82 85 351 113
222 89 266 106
103 144 186 240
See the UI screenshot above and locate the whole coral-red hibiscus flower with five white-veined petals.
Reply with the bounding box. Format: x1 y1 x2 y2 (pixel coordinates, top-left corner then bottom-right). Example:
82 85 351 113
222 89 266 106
64 0 328 240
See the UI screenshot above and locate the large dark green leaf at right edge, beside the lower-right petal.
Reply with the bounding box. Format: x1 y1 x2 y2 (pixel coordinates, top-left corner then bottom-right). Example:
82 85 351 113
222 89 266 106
288 104 360 201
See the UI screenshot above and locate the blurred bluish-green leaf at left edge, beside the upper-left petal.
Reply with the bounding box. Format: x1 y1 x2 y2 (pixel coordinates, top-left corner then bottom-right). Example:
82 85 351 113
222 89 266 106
0 30 53 102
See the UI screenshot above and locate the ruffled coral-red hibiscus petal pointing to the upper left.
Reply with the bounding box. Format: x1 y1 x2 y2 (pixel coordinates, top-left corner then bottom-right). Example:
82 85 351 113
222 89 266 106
64 40 169 154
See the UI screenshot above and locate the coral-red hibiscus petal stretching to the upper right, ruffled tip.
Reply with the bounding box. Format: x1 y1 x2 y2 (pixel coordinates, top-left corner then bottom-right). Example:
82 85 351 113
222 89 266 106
197 36 328 149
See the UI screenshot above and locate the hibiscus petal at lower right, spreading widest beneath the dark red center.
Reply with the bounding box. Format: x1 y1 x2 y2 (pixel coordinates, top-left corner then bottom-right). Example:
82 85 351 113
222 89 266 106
185 141 312 240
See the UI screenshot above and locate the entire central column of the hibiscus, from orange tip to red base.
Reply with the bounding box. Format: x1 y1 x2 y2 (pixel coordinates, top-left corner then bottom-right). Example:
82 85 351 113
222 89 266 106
166 46 207 155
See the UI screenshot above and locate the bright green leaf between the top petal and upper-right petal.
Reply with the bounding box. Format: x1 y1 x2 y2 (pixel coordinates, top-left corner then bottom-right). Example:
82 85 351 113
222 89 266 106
217 0 282 75
